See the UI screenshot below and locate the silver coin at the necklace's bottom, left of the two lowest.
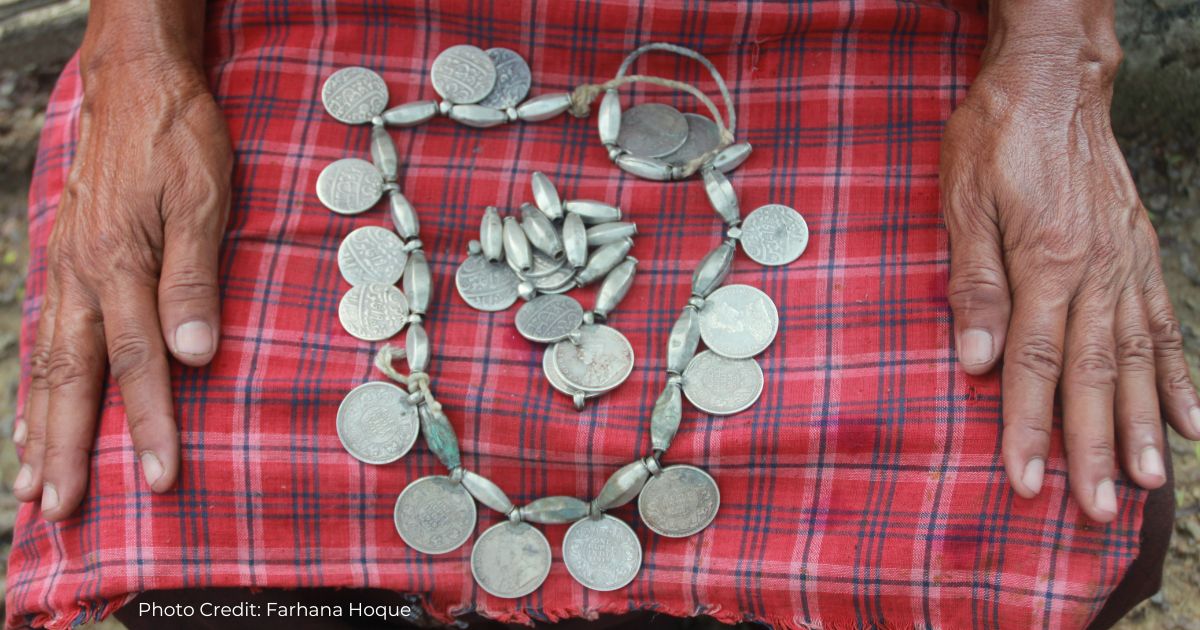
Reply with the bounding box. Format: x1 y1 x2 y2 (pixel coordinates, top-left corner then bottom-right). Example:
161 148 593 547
470 521 552 599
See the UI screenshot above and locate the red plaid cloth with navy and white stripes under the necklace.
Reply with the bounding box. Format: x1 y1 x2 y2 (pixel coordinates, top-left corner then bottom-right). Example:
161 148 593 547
7 0 1145 628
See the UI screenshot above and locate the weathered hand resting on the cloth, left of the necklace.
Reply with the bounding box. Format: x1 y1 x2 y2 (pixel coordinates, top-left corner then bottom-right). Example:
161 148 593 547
13 20 233 521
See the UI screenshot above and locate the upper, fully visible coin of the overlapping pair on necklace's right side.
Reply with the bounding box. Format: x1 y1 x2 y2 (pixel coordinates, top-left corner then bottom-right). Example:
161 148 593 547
700 284 779 359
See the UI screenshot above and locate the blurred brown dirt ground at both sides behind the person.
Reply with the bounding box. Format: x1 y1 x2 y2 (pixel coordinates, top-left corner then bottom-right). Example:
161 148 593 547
0 0 1200 630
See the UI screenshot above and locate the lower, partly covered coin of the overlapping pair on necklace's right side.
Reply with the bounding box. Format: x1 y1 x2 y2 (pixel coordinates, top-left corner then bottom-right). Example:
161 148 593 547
683 350 762 415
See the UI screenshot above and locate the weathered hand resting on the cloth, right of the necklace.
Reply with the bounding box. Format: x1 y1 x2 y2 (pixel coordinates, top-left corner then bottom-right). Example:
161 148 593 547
941 2 1200 522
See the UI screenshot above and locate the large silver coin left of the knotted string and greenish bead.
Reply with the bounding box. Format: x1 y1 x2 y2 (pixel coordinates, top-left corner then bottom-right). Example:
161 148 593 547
337 380 420 464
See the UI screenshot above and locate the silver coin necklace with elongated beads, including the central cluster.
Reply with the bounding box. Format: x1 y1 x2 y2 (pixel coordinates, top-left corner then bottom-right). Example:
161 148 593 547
317 43 808 598
